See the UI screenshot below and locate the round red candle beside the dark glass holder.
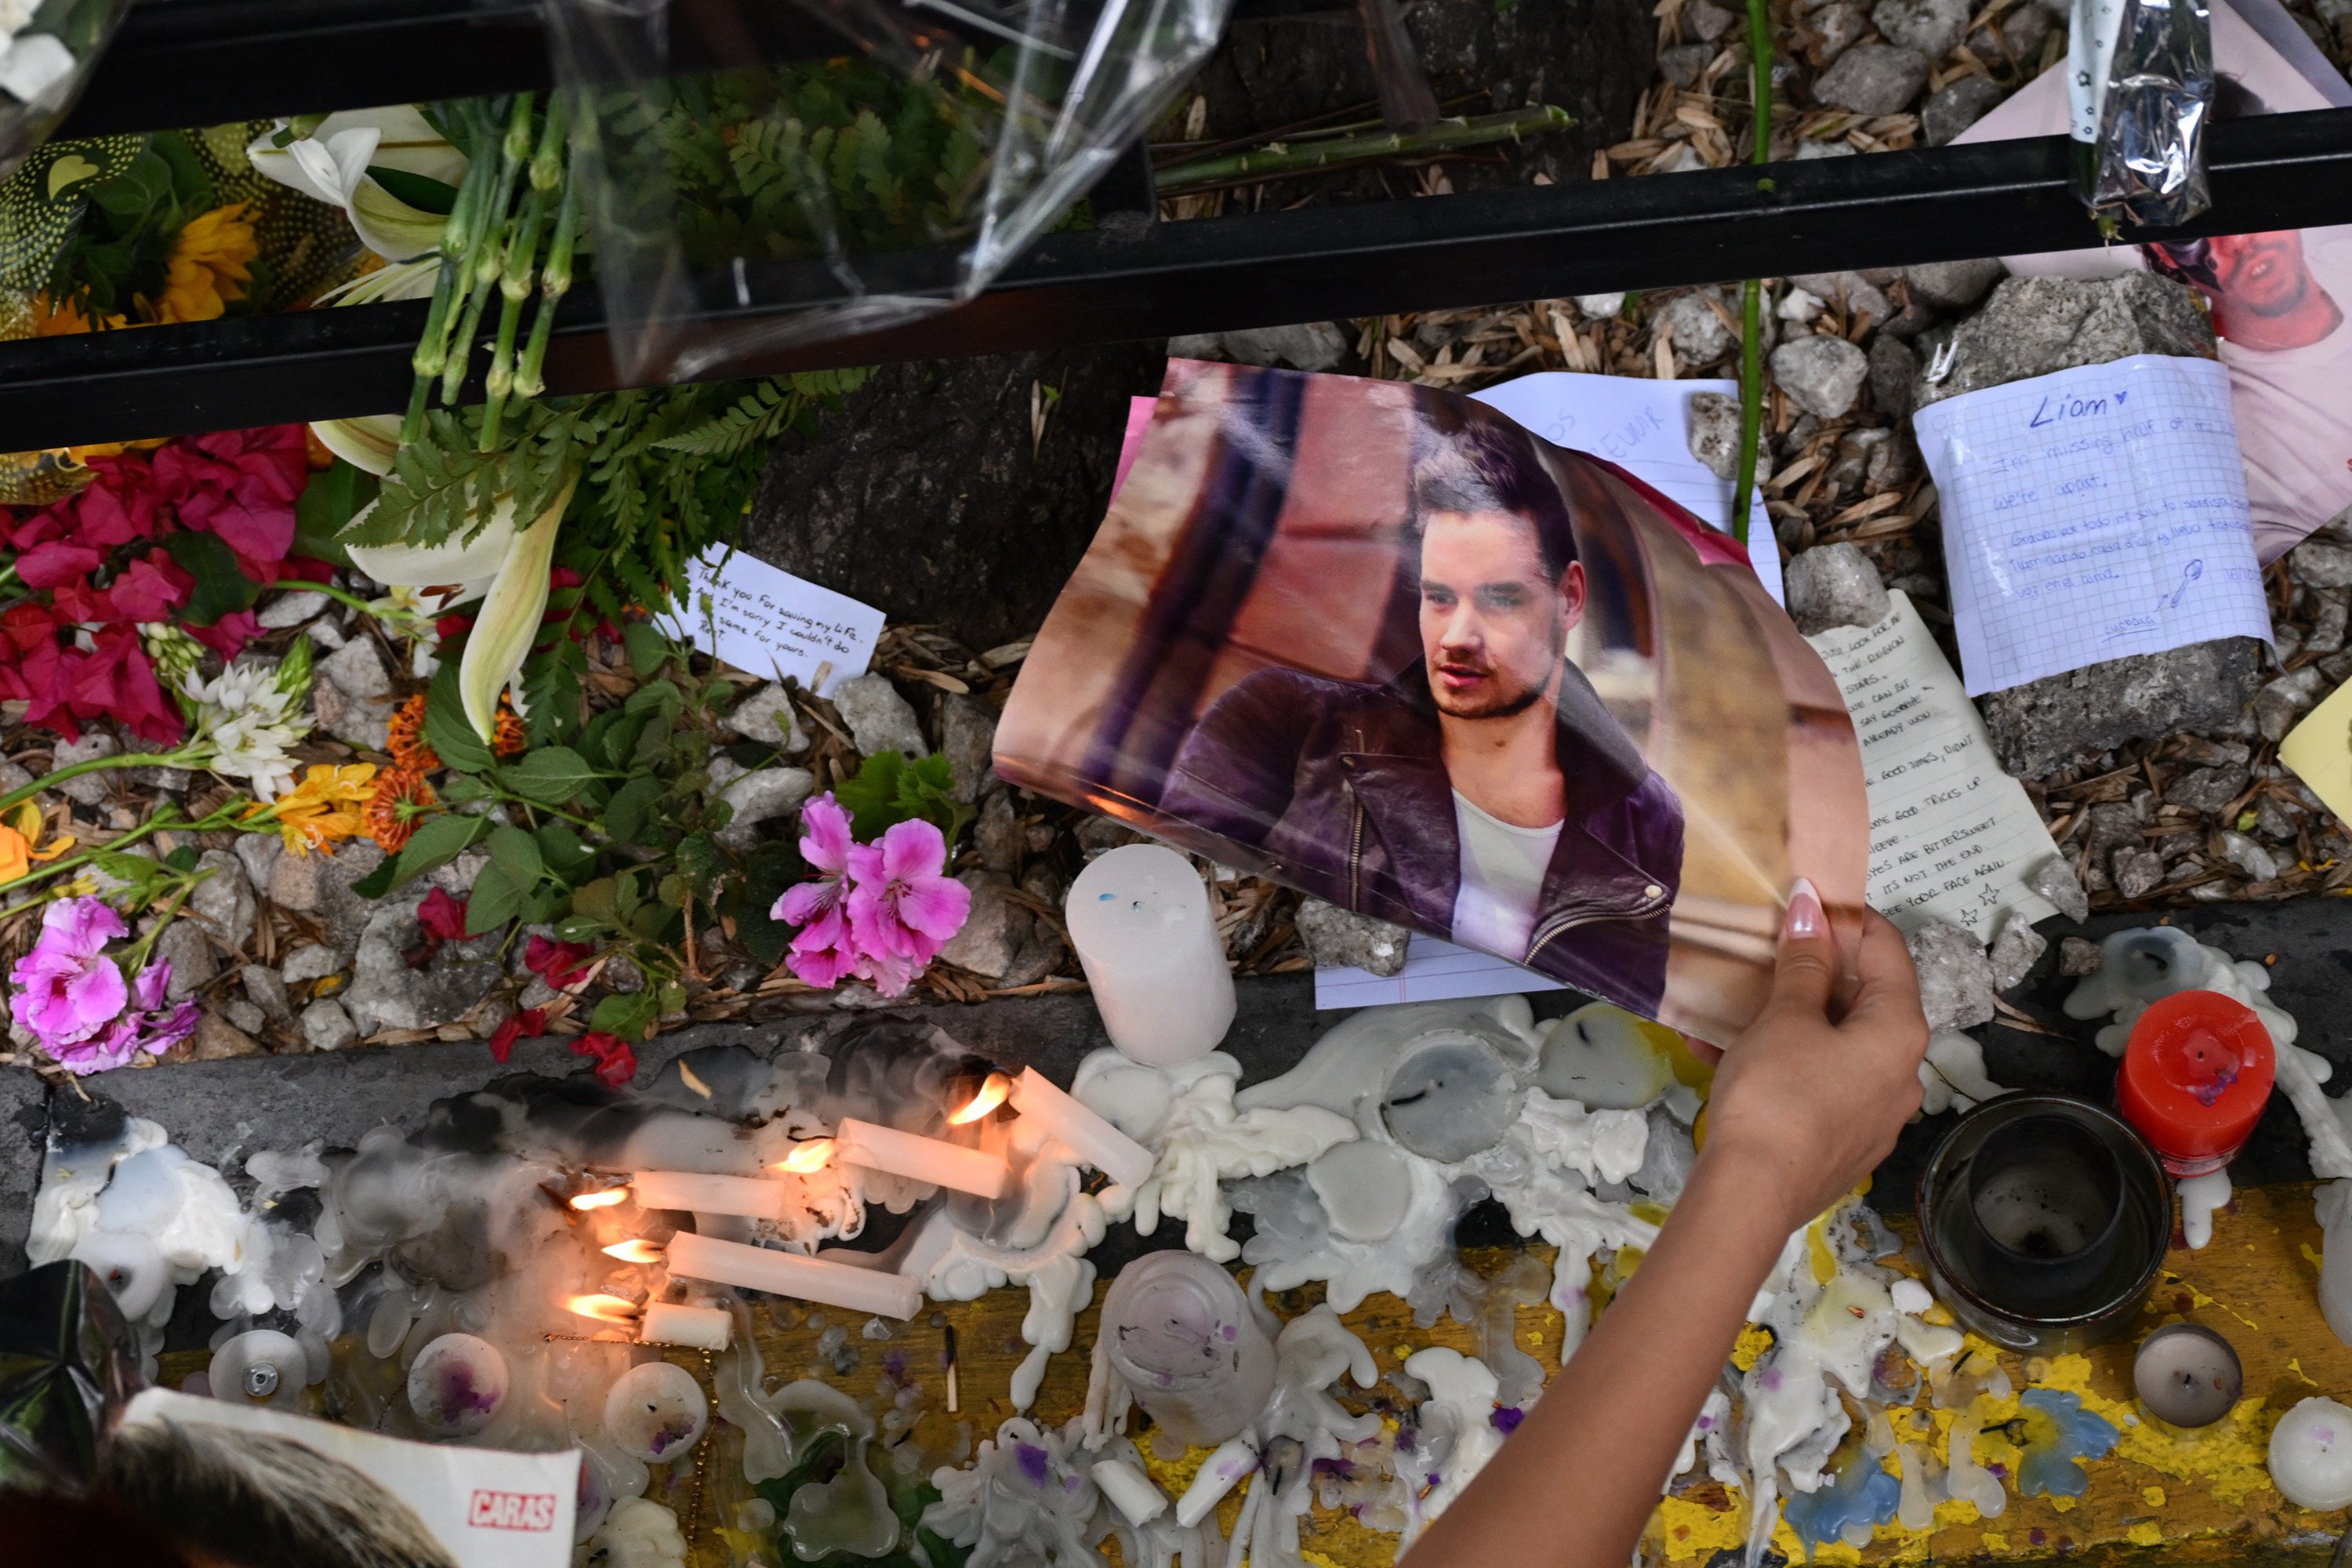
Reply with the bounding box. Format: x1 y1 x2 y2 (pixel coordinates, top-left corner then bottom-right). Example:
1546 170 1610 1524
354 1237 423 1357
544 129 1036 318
2114 989 2277 1175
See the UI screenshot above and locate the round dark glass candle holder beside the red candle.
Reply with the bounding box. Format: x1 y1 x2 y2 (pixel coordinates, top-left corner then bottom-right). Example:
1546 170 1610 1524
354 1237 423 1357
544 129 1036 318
1919 1093 2173 1354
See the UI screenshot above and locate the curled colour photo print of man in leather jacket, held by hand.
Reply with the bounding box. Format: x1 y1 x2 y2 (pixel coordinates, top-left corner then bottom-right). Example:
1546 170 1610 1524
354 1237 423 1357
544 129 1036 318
995 360 1867 1039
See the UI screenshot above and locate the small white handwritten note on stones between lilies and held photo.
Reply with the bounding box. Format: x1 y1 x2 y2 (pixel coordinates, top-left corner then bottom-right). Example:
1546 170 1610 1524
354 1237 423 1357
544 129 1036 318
666 553 882 696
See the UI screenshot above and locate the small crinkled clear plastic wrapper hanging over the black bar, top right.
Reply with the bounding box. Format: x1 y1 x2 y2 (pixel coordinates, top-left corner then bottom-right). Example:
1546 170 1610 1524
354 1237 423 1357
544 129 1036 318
2067 0 2213 228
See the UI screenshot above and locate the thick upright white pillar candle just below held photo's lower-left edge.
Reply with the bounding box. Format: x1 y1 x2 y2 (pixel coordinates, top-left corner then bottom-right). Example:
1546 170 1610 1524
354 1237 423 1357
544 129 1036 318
1063 844 1232 1067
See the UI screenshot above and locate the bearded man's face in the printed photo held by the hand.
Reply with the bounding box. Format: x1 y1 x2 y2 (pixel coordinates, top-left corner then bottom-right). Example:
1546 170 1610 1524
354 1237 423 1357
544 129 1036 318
1421 513 1585 720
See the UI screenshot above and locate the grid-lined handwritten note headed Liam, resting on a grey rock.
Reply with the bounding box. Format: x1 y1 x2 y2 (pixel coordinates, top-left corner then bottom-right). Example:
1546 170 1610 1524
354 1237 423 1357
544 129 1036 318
1912 355 2270 696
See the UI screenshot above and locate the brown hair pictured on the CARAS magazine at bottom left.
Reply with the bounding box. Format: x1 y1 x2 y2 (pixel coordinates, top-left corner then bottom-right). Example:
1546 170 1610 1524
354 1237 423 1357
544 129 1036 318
99 1420 456 1568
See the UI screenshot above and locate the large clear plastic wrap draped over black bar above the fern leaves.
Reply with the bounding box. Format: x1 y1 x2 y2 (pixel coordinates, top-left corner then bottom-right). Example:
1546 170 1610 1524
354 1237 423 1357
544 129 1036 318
539 0 1230 381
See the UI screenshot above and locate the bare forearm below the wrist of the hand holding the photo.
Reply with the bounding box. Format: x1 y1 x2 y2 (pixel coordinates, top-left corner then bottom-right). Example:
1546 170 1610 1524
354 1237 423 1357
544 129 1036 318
1411 1156 1788 1568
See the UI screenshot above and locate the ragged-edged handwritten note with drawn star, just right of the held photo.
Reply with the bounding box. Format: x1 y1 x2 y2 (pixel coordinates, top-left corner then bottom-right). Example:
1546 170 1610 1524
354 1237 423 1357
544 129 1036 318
1809 590 2058 942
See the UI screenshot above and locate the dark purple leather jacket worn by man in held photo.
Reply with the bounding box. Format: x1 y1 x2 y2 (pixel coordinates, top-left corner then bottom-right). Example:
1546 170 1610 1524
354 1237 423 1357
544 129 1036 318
1160 663 1682 1015
